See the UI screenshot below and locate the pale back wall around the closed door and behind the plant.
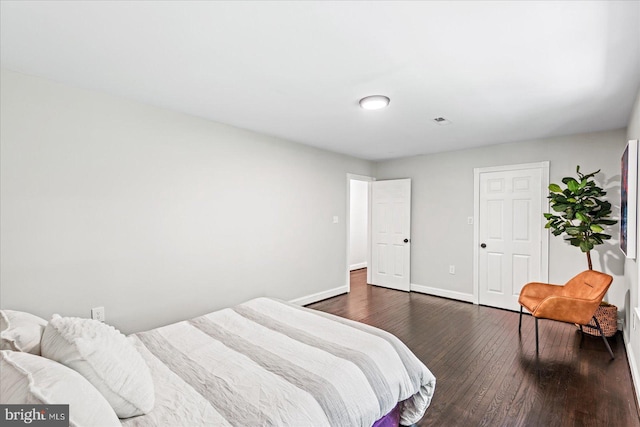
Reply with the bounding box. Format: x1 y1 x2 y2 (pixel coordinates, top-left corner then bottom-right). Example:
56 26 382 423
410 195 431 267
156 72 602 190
375 129 626 307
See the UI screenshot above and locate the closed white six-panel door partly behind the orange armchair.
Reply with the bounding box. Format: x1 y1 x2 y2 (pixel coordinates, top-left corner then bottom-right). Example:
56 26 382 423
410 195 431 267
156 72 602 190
476 162 548 310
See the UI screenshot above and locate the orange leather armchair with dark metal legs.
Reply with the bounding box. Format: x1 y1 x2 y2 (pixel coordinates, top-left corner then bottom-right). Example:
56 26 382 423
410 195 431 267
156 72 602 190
518 270 614 359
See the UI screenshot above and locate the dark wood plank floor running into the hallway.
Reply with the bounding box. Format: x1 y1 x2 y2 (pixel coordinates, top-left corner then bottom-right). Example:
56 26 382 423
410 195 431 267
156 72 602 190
309 270 640 427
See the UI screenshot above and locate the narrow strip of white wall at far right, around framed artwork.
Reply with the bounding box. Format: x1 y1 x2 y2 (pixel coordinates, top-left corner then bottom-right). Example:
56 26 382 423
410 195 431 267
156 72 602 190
624 86 640 402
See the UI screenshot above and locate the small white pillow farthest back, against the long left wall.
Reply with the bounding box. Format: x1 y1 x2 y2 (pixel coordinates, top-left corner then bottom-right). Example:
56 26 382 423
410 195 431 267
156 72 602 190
0 310 47 355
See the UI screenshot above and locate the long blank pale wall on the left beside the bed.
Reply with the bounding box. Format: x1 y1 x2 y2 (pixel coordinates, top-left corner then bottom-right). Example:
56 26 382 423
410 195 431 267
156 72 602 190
0 70 371 332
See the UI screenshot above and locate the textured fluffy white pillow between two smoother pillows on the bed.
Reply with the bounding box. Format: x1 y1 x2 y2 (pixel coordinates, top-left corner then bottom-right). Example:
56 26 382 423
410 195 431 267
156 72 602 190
42 314 155 418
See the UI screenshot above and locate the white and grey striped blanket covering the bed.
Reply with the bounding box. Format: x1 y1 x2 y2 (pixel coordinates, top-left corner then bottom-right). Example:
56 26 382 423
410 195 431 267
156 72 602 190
122 298 435 426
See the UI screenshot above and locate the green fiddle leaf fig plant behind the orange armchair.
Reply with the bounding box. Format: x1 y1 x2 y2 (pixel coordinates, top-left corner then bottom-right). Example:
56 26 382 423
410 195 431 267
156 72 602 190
544 166 618 270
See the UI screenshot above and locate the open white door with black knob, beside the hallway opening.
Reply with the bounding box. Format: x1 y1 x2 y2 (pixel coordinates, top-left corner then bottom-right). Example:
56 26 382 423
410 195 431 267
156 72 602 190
371 179 411 292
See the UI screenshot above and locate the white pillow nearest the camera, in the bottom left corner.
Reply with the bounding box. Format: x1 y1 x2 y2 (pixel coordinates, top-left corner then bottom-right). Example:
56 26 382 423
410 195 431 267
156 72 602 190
0 351 121 427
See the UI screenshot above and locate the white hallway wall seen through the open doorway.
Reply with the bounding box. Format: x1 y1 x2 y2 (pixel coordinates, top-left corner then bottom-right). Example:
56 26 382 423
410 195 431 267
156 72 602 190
349 179 369 270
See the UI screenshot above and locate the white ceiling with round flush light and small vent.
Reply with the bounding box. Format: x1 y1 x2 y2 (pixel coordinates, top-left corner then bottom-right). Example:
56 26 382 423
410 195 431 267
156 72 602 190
0 0 640 160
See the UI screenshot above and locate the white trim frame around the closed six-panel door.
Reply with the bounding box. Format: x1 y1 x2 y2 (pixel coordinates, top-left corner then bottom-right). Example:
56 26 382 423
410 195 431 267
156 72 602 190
472 161 549 305
